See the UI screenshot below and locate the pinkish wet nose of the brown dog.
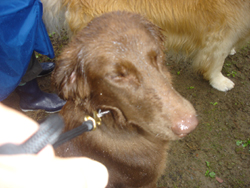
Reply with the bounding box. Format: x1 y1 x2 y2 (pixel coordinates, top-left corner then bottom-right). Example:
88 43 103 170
172 115 198 138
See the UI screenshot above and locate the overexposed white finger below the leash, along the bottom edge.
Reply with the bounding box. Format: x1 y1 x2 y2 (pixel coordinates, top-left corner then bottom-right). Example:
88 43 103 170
0 155 108 188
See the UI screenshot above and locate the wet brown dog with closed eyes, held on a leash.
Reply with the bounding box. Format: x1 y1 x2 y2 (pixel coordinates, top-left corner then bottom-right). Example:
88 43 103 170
52 12 197 188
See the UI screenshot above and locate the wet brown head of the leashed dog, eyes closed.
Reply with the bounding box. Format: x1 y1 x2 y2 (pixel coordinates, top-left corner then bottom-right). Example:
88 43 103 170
52 12 197 139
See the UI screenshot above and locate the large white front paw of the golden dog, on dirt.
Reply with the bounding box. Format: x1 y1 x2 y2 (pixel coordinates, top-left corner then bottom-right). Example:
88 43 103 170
210 73 234 92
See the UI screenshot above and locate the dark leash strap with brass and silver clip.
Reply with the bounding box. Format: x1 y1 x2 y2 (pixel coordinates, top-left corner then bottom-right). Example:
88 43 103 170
0 110 109 155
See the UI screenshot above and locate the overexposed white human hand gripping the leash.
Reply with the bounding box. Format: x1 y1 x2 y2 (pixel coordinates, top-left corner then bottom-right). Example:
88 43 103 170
0 103 108 188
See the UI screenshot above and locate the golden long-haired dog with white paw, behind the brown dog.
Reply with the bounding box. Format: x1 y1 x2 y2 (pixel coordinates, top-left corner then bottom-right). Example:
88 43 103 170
42 0 250 91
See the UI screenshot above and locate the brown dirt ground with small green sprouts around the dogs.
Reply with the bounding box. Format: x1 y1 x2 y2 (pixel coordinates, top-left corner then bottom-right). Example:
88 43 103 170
4 34 250 188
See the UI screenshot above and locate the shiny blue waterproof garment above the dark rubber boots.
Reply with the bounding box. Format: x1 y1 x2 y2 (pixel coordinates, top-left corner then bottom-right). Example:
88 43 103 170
0 0 54 101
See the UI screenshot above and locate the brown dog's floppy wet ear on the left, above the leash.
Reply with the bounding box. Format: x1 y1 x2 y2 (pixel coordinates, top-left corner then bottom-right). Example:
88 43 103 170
52 43 89 100
